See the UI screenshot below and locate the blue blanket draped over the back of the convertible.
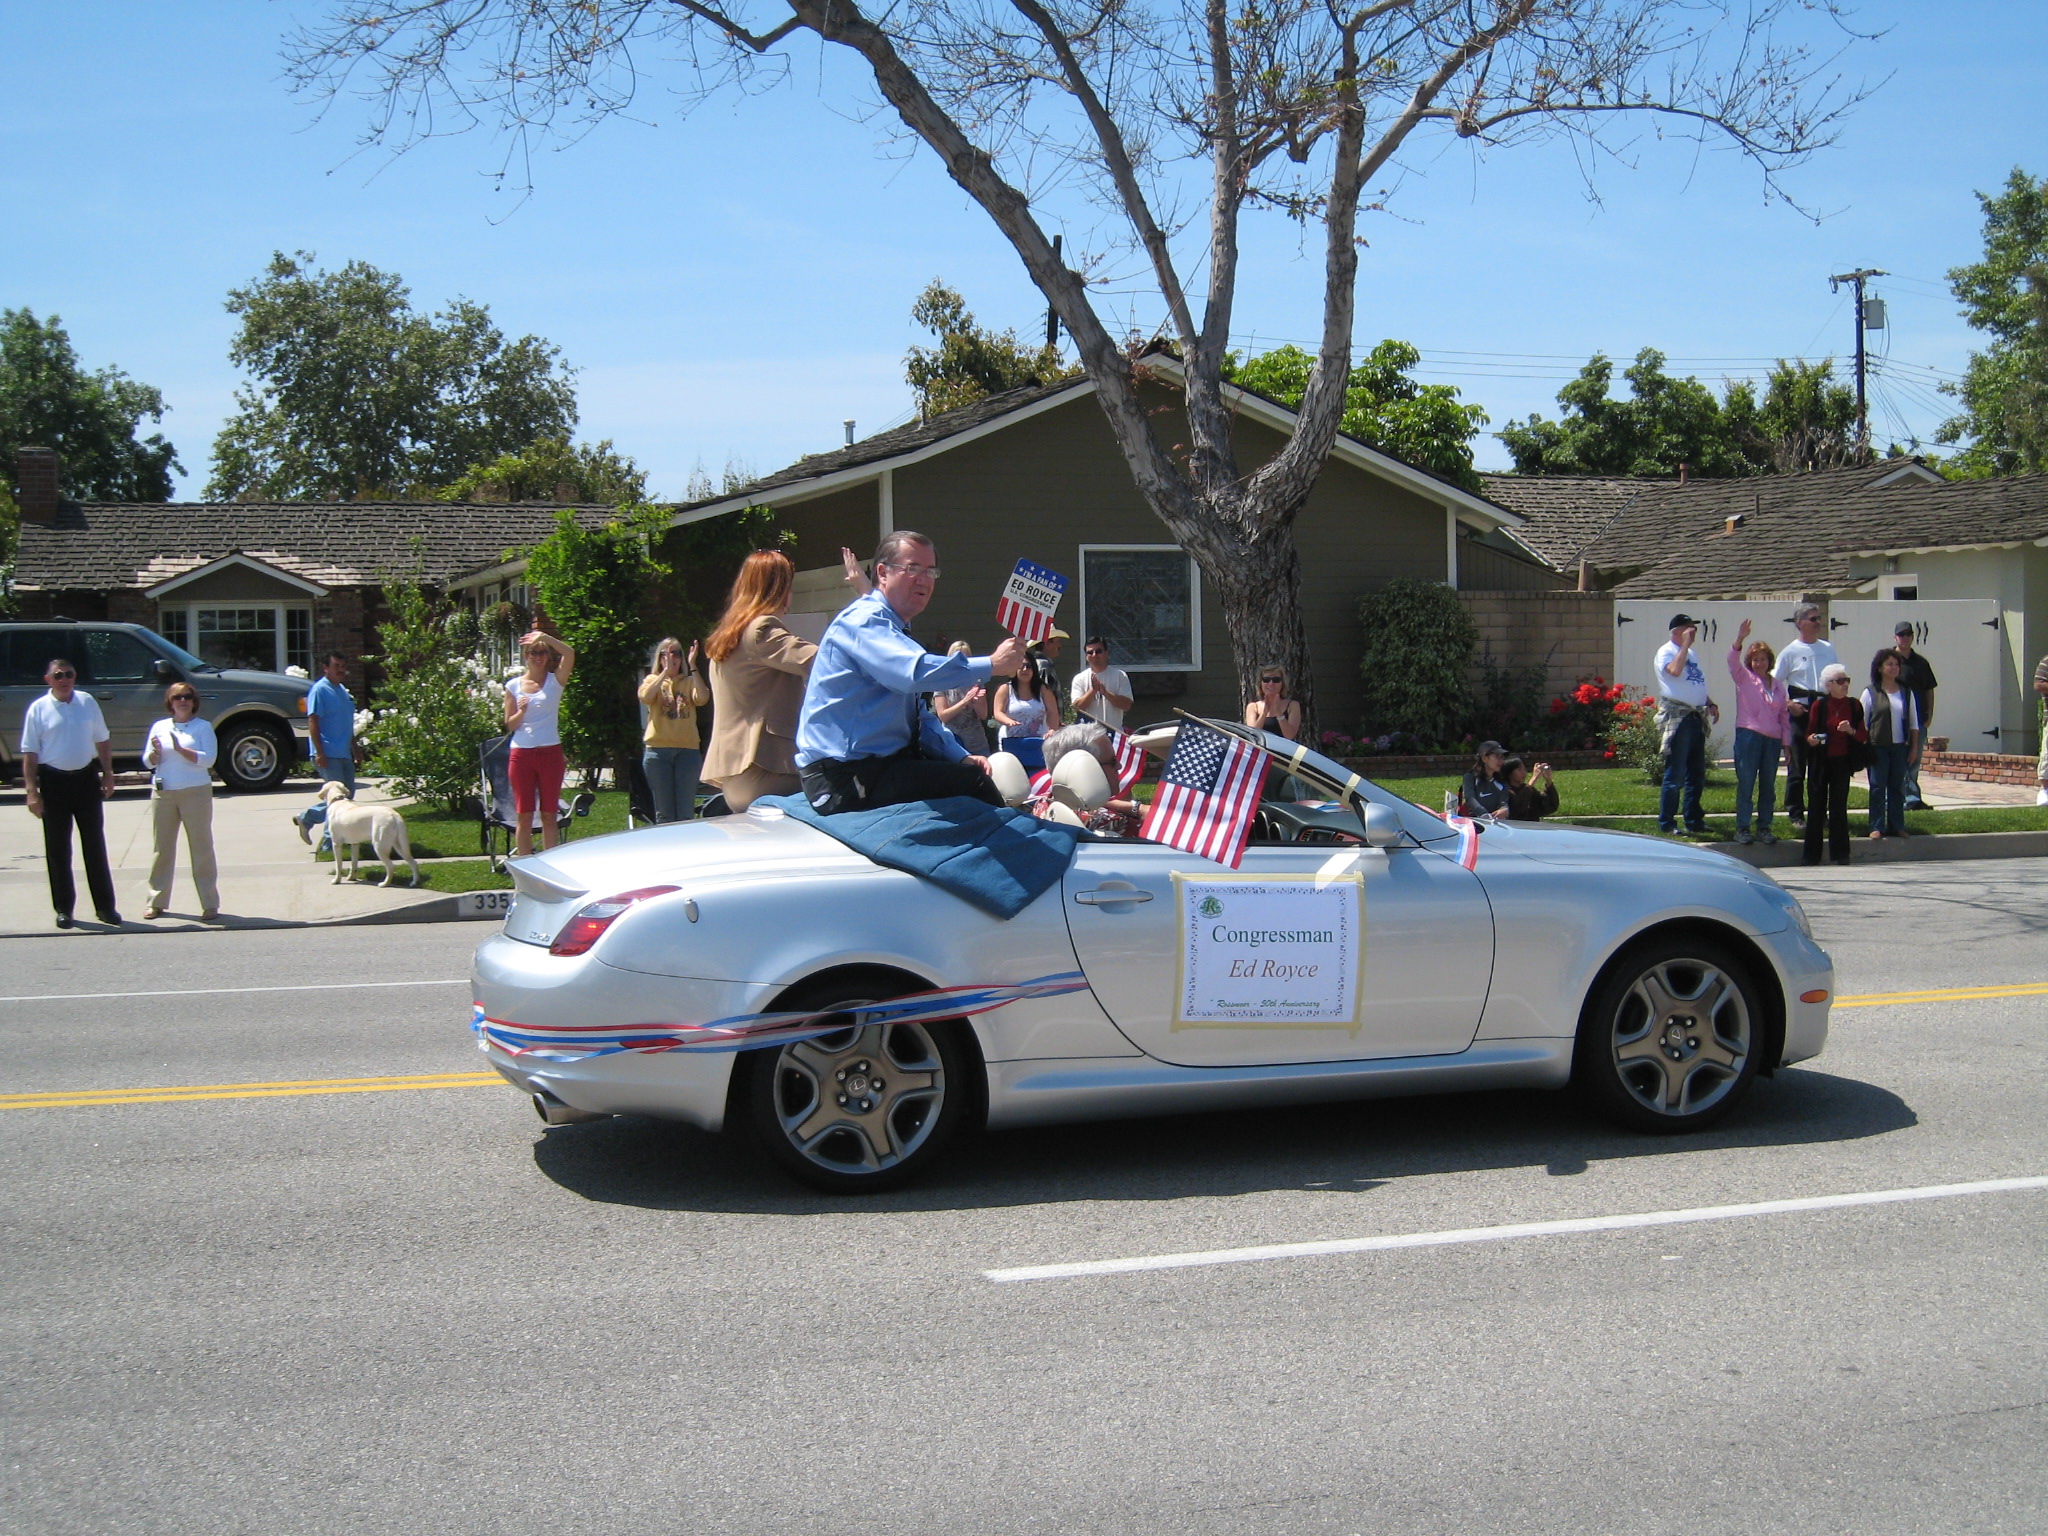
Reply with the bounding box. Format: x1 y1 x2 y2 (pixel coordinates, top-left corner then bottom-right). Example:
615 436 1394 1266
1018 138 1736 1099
762 795 1092 918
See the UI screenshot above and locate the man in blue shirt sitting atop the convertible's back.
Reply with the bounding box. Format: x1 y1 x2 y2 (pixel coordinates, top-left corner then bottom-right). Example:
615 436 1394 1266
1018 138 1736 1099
797 530 1024 815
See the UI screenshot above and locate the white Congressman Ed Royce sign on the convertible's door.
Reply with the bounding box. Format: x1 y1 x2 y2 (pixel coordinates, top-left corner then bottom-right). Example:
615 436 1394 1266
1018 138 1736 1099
1174 874 1366 1034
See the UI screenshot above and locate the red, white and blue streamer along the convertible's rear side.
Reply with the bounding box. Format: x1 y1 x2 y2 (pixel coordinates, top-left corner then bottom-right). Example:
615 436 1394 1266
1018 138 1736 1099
469 971 1087 1061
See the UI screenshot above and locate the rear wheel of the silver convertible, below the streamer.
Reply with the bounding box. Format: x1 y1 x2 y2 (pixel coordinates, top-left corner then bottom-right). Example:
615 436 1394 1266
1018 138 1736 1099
743 983 975 1194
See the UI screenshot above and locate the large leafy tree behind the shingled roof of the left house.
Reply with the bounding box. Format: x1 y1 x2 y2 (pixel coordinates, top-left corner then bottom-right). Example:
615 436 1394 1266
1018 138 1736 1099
207 252 575 500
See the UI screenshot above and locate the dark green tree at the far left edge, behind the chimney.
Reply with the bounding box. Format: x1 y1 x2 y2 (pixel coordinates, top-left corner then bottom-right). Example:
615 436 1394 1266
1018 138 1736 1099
0 309 184 502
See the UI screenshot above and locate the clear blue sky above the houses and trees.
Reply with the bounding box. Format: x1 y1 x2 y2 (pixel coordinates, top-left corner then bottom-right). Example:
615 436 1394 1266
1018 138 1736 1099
0 0 2048 496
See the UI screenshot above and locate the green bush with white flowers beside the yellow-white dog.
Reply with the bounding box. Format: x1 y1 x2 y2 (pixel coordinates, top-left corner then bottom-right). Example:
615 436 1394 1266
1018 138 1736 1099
362 569 504 811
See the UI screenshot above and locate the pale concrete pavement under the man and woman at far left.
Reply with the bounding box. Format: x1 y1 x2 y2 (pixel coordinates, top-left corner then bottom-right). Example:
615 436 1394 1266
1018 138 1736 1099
0 774 453 938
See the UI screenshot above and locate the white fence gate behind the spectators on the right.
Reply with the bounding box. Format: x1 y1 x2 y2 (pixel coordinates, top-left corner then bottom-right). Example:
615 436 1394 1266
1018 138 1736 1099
1614 598 2005 752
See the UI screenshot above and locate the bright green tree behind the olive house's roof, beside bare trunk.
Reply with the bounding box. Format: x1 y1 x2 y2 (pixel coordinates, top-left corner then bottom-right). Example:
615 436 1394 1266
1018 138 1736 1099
1223 340 1487 489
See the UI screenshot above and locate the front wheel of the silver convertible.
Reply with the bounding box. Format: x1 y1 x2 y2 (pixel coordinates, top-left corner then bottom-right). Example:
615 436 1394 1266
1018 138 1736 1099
1571 934 1763 1135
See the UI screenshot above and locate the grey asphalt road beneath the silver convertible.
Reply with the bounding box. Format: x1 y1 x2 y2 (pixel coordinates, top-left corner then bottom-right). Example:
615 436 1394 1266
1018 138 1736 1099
0 860 2048 1536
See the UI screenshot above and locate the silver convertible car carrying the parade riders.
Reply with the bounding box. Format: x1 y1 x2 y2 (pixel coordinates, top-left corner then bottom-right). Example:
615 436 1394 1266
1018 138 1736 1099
473 721 1835 1192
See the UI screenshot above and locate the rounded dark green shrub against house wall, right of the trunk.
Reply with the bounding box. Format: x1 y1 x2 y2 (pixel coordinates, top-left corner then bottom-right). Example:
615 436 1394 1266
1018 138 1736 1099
1358 575 1479 741
